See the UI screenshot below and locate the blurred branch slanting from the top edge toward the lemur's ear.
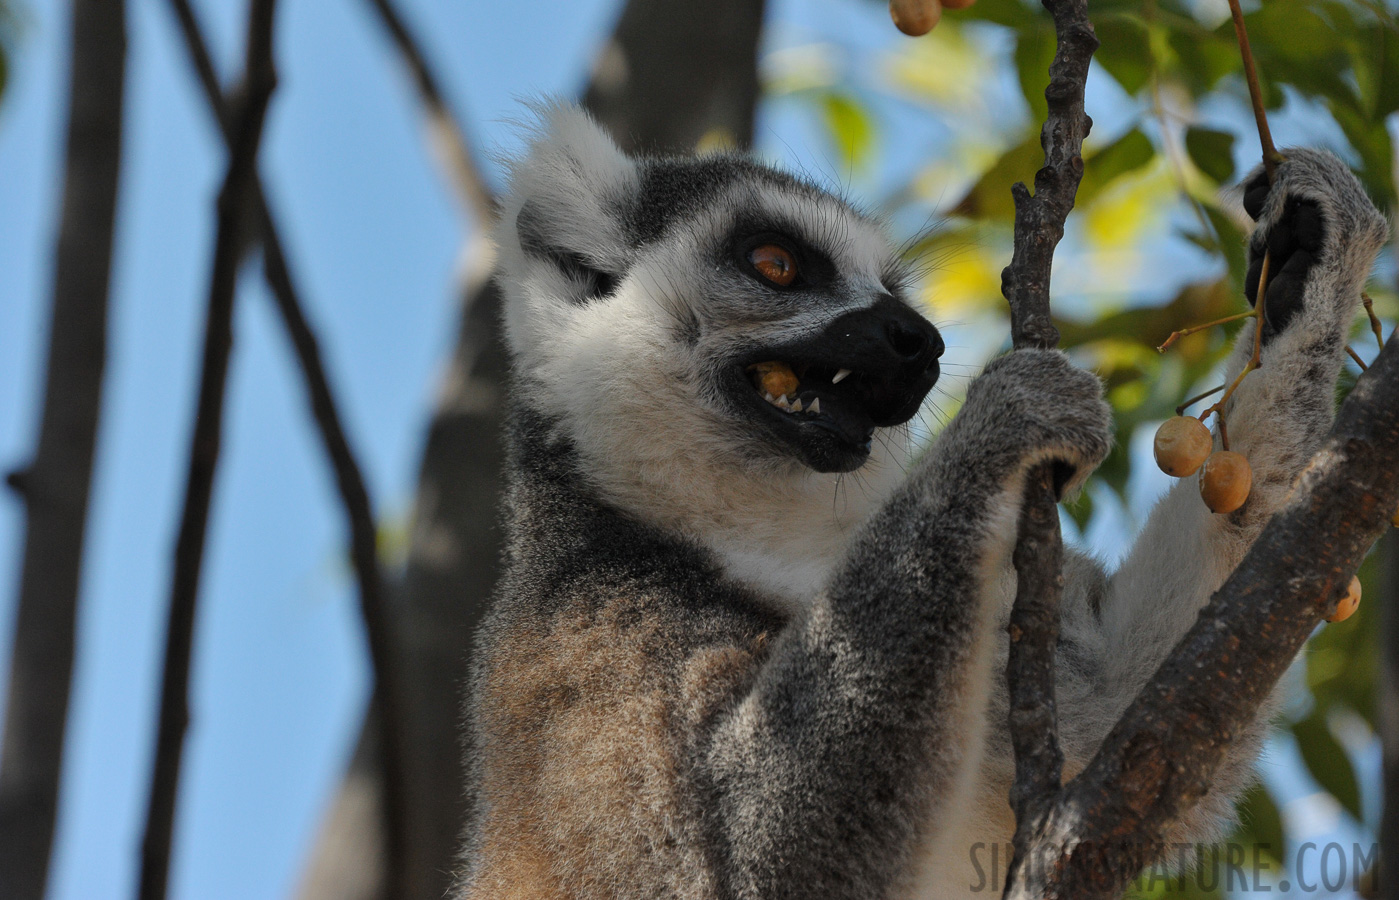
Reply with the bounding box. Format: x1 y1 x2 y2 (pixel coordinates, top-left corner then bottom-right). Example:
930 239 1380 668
369 0 495 225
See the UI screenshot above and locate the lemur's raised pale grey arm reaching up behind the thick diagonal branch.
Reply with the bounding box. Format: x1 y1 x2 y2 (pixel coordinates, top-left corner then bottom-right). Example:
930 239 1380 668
1059 150 1388 837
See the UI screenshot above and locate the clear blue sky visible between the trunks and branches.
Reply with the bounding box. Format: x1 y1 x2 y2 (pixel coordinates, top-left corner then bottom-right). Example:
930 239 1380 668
0 0 1382 900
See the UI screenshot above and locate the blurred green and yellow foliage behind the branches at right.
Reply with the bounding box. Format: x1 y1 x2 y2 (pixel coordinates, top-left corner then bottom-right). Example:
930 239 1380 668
789 0 1399 897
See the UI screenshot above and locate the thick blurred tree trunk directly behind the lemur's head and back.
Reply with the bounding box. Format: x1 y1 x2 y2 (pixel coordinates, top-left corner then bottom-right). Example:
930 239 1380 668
299 0 764 900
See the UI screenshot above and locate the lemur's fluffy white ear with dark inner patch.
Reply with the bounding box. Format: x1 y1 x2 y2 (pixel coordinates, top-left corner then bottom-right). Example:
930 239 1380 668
501 104 639 302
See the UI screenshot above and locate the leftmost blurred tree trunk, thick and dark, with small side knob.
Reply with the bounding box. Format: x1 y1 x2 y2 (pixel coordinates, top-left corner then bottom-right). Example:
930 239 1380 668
0 0 126 900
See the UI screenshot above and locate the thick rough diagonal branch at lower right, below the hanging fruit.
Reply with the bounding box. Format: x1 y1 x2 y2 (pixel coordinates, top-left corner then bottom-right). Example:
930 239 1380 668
1035 336 1399 900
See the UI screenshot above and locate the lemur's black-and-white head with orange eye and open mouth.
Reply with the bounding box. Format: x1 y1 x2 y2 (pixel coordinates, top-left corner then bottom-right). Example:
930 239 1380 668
501 109 943 472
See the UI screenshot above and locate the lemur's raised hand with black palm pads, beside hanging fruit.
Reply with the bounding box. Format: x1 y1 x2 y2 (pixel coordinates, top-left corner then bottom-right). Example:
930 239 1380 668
1244 148 1388 344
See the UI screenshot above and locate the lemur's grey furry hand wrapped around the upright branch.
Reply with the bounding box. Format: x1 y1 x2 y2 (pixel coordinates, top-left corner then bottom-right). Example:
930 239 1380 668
958 350 1112 494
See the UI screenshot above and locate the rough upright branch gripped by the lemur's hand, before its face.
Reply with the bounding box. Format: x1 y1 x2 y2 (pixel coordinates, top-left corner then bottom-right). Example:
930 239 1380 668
1000 0 1098 897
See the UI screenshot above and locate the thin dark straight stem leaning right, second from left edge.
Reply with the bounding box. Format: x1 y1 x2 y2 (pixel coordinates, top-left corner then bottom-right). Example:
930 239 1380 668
140 0 277 900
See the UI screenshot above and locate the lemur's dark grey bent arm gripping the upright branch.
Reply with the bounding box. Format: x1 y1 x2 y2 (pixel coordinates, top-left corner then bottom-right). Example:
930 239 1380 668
700 351 1111 900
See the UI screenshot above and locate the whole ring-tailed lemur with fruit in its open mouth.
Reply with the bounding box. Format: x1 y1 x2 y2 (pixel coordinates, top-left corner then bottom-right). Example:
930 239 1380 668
459 108 1386 900
